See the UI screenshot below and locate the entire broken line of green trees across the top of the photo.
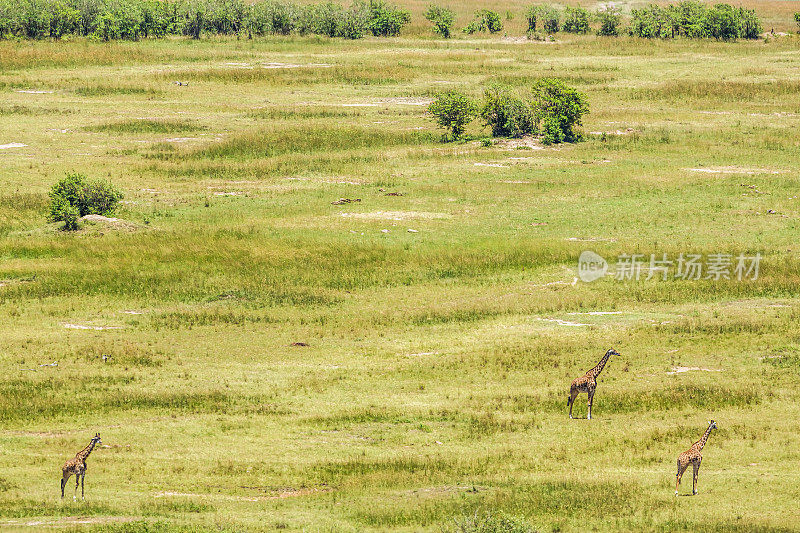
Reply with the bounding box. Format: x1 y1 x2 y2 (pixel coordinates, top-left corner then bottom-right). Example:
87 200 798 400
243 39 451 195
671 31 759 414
0 0 762 41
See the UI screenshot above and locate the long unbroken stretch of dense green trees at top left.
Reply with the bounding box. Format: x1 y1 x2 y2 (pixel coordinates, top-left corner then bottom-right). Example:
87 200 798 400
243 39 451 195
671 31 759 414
0 0 411 41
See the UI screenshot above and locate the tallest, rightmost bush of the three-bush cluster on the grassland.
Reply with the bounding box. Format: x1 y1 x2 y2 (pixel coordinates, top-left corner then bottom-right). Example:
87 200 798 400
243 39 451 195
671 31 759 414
533 79 589 144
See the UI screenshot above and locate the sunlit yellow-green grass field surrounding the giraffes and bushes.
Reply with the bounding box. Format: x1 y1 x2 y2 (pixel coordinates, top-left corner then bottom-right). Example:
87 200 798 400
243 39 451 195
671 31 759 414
0 10 800 532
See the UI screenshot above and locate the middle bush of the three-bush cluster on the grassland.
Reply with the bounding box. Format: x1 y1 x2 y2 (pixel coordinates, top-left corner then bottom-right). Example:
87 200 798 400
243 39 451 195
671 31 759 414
481 85 536 137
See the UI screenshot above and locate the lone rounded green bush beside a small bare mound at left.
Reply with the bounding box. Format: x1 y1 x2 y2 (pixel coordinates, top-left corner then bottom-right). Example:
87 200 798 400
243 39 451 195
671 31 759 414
48 173 123 230
